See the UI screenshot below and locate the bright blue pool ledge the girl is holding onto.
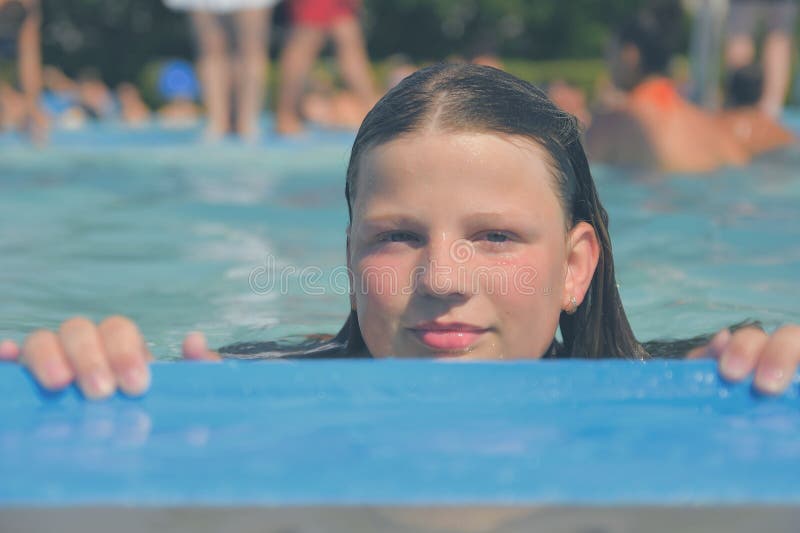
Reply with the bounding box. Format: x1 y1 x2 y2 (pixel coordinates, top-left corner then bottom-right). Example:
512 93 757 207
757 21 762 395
0 361 800 506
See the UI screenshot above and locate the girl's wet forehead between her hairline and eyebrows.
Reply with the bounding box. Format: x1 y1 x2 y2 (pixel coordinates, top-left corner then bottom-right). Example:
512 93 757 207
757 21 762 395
355 131 556 214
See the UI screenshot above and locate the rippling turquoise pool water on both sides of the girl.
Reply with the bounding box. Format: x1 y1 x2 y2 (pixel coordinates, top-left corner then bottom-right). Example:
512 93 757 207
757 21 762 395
0 115 800 358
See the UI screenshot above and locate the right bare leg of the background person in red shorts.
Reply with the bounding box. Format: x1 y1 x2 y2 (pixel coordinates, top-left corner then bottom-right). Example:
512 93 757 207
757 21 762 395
331 18 377 107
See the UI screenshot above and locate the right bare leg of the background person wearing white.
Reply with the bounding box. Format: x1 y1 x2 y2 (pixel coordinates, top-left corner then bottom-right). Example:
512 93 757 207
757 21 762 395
231 9 272 140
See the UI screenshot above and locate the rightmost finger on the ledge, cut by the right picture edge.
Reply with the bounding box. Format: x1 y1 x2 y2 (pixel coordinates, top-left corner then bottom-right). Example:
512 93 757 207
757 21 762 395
754 326 800 394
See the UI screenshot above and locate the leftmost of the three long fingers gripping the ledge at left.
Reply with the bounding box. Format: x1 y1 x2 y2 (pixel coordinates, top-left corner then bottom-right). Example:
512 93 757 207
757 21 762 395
20 330 75 391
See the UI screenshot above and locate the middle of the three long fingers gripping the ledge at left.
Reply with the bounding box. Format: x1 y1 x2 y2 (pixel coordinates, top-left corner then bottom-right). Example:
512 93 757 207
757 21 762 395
59 318 116 399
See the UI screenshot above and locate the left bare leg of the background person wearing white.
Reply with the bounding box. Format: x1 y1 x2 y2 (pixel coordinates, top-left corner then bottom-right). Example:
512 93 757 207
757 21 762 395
192 12 231 140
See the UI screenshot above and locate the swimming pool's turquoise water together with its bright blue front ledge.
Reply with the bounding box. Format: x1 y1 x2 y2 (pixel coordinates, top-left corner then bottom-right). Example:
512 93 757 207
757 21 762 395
0 119 800 516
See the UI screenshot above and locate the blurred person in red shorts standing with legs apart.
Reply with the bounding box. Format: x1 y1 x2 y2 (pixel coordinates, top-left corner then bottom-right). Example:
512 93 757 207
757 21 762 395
275 0 377 135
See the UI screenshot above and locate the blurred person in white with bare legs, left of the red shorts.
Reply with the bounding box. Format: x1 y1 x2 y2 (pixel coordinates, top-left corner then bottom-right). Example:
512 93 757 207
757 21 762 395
164 0 279 141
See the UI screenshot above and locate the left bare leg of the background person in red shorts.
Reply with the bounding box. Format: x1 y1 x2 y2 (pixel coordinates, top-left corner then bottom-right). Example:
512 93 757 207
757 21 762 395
275 26 326 135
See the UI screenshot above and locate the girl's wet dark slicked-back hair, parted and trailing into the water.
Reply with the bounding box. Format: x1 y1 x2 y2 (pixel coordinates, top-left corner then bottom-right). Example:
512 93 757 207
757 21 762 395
223 64 648 358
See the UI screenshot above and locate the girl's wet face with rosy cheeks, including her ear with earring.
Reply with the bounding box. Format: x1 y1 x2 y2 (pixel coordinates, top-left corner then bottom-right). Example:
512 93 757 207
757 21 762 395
348 129 598 359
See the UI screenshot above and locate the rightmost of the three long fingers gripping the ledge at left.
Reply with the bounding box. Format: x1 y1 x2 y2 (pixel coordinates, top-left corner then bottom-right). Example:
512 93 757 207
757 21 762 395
97 316 150 396
